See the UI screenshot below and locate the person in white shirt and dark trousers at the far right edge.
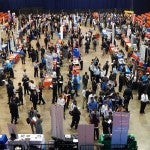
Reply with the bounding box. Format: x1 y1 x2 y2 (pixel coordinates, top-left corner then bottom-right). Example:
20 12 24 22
140 91 149 114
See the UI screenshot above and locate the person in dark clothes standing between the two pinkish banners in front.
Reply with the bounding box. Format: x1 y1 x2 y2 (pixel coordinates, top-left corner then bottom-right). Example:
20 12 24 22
70 106 81 129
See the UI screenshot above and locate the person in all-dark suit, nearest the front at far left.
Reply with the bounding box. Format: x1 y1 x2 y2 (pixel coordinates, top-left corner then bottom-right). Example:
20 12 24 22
9 98 18 124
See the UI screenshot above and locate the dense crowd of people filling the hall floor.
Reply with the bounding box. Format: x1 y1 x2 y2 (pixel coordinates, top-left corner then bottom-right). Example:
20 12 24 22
0 9 150 139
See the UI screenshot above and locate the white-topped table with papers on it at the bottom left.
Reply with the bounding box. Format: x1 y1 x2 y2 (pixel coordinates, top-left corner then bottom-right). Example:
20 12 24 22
7 134 45 150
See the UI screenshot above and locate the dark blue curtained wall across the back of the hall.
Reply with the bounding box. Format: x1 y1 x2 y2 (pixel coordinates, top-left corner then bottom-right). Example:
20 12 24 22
0 0 150 13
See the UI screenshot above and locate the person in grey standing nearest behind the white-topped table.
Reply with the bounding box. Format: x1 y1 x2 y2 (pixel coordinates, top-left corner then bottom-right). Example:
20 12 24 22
35 114 43 134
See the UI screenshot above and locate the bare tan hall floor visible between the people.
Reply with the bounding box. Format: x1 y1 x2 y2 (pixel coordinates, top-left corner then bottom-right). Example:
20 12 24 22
0 24 150 150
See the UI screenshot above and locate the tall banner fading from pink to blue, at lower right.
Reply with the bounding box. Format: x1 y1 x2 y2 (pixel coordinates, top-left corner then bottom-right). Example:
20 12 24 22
111 112 130 147
